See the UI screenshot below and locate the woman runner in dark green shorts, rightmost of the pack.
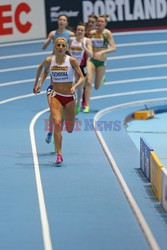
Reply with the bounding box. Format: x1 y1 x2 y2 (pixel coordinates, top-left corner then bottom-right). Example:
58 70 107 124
84 16 116 113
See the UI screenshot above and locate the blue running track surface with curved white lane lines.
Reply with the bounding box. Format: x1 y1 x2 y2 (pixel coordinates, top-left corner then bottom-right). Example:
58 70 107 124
0 30 167 250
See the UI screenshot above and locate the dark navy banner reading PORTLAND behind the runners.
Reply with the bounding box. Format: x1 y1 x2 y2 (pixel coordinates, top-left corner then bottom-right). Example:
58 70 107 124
45 0 167 32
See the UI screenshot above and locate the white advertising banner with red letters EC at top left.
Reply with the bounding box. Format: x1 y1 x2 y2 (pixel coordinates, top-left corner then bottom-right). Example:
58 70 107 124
0 0 46 43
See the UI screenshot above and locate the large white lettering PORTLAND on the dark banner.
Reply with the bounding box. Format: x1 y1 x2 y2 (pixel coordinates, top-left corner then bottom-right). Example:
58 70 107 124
82 0 167 22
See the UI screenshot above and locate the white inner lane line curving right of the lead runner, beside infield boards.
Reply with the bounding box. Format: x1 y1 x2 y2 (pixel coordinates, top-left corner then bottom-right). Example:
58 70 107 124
94 98 167 250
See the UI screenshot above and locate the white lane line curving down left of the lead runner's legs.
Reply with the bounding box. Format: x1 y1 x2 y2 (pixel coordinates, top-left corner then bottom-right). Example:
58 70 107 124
29 108 52 250
